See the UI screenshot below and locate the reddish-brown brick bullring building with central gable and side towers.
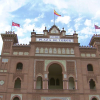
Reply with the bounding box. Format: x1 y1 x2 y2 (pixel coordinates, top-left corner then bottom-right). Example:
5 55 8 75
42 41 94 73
0 25 100 100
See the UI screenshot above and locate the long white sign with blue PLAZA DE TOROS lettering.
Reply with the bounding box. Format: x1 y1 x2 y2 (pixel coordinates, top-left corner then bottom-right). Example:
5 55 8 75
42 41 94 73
36 37 73 42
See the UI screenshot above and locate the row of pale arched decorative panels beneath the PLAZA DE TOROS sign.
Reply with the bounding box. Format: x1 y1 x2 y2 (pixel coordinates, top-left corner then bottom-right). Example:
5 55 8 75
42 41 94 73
36 47 74 55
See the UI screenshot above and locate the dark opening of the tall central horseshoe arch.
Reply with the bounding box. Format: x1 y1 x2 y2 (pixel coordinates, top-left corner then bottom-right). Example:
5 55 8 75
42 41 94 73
48 63 63 89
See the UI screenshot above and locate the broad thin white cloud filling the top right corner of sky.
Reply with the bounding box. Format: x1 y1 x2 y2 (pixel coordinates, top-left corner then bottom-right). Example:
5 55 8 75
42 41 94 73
43 0 100 16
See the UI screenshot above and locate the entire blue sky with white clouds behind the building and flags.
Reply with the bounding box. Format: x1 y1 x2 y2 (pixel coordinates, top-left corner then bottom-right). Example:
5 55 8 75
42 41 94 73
0 0 100 51
